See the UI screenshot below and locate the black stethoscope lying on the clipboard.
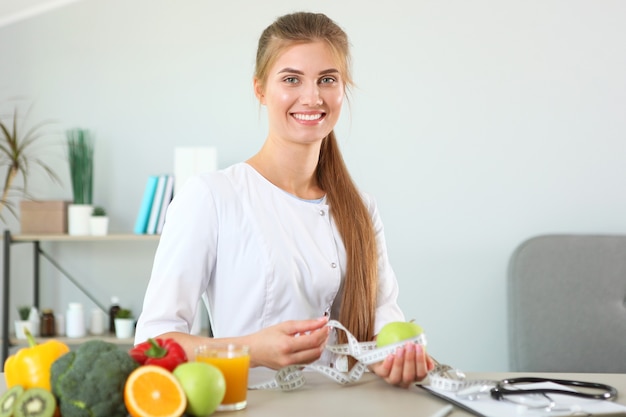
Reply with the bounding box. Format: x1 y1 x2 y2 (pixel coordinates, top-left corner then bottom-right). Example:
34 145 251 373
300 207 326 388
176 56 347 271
490 377 617 400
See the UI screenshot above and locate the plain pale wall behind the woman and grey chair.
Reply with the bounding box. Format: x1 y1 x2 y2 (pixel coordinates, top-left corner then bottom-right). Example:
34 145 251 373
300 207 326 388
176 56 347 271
0 0 626 371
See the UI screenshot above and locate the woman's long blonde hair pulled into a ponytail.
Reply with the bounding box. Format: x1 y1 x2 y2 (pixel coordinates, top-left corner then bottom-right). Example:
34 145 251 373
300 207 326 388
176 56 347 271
255 12 378 342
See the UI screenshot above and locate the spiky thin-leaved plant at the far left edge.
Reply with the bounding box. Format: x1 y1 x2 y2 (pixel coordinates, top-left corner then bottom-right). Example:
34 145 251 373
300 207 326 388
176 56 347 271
0 100 61 220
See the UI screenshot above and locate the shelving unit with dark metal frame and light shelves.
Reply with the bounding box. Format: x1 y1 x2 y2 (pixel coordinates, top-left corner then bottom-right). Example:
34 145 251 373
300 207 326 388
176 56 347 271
0 230 159 364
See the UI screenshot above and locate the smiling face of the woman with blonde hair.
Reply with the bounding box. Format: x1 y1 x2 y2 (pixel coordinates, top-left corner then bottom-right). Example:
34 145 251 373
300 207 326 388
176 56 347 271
254 42 345 144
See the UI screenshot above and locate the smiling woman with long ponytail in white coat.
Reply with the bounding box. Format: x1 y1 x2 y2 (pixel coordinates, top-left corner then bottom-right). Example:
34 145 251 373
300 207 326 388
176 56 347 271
136 13 433 387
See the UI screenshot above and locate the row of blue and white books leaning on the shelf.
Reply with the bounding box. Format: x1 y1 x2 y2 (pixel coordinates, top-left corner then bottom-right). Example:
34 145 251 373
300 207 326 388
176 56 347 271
133 174 174 235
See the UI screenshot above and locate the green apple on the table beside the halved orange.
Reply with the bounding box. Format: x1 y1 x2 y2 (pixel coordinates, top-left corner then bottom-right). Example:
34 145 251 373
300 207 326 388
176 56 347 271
173 362 226 417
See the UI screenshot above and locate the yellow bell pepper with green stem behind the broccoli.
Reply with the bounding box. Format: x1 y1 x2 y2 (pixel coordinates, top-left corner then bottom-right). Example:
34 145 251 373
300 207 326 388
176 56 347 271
4 329 70 391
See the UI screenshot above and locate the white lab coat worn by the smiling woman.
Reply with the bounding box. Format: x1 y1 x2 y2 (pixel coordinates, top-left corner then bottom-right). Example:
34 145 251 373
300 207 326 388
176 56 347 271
135 163 404 360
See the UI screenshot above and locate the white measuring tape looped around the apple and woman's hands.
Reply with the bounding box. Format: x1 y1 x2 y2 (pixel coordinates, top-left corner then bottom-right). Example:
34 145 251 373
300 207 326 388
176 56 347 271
248 320 444 391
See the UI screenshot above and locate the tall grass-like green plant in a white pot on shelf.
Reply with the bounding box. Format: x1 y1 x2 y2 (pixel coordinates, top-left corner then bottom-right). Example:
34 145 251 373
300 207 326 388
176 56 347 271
66 128 94 235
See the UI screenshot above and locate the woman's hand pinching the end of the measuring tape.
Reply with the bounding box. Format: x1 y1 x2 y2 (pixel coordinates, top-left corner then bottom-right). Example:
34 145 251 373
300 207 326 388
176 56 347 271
246 317 330 369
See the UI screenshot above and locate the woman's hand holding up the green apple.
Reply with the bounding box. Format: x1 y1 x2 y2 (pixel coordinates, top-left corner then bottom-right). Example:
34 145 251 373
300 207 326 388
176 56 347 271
370 342 435 388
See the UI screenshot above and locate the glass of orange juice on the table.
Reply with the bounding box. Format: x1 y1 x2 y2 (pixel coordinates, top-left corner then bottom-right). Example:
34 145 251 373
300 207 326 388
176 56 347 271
196 343 250 411
